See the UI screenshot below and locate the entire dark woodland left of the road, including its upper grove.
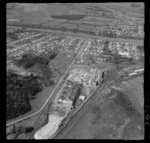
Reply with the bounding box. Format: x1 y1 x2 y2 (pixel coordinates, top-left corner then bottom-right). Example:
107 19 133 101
6 52 56 120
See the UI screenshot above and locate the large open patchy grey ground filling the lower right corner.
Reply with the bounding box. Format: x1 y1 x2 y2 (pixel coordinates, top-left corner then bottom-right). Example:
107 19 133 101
56 76 144 139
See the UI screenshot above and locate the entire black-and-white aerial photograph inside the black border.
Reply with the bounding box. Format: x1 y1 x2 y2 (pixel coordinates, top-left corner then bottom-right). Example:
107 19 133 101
6 2 145 140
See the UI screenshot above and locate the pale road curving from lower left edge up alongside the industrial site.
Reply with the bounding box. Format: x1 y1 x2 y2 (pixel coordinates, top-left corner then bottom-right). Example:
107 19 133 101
6 38 89 126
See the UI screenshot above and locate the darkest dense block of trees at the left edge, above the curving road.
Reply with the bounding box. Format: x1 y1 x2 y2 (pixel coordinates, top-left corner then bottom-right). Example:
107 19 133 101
6 72 42 120
